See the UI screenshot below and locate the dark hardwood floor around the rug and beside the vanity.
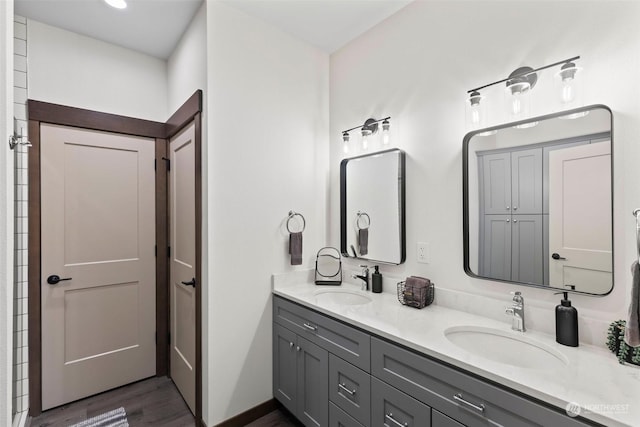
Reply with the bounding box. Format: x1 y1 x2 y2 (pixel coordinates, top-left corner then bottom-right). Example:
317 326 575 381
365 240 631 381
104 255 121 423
26 377 302 427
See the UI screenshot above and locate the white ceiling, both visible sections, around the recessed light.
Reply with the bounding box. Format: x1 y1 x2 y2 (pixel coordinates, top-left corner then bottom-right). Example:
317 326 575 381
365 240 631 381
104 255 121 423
16 0 412 59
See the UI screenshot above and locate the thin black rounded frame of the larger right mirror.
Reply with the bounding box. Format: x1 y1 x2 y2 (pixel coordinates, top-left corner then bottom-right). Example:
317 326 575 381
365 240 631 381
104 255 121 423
462 104 615 297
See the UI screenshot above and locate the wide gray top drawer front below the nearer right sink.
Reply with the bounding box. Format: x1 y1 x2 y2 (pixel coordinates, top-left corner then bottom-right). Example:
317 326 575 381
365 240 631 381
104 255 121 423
371 338 586 427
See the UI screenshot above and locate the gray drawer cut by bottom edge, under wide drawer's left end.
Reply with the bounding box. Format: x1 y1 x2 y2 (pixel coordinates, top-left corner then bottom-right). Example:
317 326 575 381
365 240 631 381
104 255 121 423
371 378 431 427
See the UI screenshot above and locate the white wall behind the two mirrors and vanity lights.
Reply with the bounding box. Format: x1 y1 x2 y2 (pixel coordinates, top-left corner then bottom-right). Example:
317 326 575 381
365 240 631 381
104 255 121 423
330 1 640 345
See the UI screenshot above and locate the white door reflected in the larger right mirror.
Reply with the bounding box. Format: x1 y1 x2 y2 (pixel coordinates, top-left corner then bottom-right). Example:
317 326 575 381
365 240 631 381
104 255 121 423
549 141 612 293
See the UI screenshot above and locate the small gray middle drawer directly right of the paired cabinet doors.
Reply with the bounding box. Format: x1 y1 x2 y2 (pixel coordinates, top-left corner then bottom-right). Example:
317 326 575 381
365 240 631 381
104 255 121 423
329 354 371 426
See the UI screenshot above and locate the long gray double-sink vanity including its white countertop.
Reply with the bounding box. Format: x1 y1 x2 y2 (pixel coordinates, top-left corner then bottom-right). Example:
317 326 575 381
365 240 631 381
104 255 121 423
273 278 640 427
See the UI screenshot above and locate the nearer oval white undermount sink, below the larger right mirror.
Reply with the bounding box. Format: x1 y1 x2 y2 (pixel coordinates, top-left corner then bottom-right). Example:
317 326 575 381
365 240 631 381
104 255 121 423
444 326 569 370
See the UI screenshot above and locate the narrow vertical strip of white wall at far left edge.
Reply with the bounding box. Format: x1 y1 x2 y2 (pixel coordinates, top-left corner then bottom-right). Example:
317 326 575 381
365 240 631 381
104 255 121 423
0 1 14 426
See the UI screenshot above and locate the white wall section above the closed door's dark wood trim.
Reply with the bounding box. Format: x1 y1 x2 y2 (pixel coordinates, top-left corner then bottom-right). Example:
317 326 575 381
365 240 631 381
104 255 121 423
27 19 168 122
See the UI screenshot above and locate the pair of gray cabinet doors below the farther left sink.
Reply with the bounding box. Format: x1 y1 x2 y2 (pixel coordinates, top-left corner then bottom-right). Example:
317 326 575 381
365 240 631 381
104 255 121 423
273 325 329 426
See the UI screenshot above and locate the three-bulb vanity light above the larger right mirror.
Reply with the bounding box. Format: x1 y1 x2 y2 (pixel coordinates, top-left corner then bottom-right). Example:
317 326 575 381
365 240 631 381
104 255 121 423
467 56 580 129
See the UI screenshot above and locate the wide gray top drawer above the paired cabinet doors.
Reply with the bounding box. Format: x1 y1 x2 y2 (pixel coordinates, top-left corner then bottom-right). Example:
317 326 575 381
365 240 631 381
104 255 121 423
273 296 371 372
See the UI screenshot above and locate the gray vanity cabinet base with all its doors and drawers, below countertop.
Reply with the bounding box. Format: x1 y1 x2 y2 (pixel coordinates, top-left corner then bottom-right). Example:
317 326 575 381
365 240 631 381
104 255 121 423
273 296 593 427
